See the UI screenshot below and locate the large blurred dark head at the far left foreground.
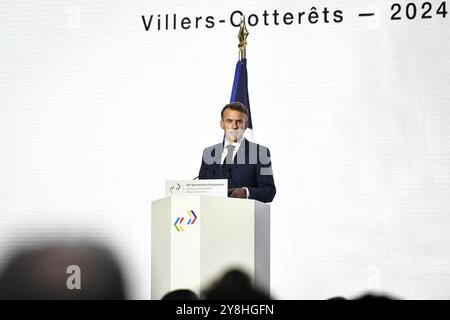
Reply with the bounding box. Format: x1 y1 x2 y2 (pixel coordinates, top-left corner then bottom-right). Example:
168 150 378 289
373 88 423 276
0 244 126 300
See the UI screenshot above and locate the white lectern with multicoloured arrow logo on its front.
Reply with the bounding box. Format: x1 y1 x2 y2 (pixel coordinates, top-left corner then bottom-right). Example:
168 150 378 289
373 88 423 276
151 195 270 299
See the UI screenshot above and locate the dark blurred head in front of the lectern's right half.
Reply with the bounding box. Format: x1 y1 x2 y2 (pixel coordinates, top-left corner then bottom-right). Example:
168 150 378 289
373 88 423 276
203 269 270 300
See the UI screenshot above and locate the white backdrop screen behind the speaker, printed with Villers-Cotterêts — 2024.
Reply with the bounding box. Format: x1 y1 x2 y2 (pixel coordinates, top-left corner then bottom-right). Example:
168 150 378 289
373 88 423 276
0 0 450 299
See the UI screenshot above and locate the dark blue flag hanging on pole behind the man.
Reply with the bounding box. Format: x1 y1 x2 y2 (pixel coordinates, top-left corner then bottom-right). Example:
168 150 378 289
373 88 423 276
230 59 253 141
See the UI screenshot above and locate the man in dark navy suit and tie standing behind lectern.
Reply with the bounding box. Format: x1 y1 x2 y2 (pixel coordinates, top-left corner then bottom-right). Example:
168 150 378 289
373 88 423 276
199 102 276 202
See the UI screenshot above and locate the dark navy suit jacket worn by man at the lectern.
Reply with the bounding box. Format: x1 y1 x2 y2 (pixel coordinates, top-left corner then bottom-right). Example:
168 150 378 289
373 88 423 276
199 139 276 202
